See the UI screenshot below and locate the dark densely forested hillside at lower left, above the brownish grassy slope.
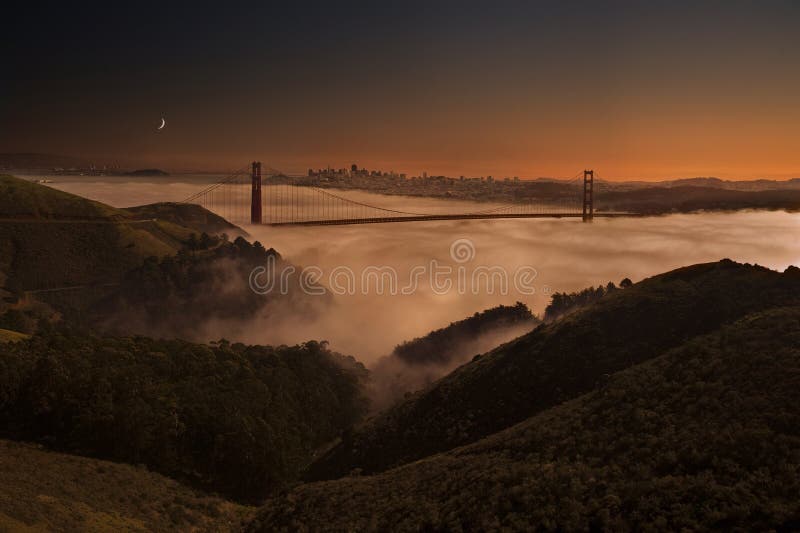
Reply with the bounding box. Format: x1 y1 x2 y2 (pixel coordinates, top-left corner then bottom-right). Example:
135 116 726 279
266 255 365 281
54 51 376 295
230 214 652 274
0 334 366 501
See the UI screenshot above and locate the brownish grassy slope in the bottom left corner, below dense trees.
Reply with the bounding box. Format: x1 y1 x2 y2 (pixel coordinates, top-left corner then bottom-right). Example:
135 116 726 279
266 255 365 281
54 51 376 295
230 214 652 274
0 440 252 532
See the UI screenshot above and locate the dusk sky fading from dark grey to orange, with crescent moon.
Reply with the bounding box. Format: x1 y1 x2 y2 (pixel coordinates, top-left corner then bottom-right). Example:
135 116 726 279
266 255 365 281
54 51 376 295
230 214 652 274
0 1 800 179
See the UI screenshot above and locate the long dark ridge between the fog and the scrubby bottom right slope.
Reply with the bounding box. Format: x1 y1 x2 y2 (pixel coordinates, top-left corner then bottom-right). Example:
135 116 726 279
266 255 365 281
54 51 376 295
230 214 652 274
309 260 800 479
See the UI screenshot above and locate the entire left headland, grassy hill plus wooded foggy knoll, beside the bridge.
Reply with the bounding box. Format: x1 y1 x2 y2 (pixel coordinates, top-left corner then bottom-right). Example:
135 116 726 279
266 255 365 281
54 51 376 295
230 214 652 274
0 177 330 342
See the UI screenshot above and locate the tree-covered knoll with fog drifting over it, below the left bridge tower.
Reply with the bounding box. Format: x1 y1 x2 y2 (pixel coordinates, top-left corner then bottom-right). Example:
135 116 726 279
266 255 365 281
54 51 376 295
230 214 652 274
90 234 324 341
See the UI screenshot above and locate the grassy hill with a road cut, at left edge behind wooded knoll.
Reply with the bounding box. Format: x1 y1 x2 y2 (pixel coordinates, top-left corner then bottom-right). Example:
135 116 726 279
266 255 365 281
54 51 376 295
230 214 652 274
0 176 241 292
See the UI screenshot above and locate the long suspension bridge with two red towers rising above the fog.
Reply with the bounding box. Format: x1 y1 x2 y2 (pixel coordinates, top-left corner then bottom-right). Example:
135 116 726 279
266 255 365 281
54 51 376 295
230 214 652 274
183 162 635 226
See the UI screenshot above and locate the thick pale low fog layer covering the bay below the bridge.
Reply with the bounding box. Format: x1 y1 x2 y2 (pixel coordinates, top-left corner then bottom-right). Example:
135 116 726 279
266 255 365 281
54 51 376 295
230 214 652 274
39 178 800 363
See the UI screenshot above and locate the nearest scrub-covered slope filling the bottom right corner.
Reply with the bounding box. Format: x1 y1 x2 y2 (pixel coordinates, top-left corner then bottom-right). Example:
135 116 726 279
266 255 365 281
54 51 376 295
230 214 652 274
250 306 800 532
